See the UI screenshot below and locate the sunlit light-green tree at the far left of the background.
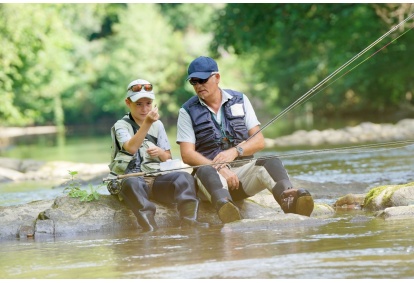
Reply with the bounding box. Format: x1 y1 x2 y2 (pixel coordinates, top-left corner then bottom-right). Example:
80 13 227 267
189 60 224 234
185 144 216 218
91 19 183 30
0 4 105 128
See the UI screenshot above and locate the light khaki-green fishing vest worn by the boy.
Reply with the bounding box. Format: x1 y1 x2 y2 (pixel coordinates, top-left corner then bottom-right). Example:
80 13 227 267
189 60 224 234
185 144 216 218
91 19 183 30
108 114 161 175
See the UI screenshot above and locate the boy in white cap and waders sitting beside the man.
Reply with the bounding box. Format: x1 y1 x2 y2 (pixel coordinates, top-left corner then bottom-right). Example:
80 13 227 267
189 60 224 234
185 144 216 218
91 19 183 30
110 79 208 231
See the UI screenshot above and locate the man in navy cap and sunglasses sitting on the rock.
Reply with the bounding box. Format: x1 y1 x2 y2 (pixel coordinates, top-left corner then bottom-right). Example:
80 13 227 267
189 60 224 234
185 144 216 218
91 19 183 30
177 56 314 223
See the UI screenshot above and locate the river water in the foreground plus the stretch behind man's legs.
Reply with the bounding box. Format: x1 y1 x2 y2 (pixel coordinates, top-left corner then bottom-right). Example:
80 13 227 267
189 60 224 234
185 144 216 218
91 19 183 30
0 143 414 279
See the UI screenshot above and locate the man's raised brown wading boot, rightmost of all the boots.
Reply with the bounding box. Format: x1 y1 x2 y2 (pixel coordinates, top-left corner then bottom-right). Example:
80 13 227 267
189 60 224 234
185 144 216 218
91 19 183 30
275 189 314 216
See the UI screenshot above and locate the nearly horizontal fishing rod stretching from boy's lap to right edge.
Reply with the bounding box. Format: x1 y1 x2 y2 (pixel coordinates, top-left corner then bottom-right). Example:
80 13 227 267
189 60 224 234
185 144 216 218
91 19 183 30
103 140 414 182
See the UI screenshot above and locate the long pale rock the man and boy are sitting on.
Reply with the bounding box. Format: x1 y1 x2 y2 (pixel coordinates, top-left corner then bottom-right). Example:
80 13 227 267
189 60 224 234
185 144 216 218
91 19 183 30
0 191 334 242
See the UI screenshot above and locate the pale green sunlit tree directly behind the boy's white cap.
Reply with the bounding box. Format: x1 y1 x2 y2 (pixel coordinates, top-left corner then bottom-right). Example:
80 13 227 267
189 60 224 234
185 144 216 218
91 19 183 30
84 4 189 127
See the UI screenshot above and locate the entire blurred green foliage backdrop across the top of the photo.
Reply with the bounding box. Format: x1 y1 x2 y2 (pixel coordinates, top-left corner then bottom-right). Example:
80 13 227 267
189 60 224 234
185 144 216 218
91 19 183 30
0 3 414 129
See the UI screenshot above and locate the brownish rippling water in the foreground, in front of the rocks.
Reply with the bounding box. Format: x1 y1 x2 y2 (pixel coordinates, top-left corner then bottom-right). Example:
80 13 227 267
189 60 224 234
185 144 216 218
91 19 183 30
0 212 414 279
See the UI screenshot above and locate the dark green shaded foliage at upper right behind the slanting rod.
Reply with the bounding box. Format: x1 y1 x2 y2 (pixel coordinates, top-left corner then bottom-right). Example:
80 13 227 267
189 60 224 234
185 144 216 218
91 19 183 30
211 3 413 117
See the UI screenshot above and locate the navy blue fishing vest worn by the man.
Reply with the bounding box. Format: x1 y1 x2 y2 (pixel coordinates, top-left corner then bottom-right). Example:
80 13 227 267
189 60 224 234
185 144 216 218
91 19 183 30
182 89 248 159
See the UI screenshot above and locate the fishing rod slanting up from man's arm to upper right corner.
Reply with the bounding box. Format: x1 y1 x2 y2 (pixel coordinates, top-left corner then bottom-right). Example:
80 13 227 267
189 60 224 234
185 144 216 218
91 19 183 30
243 13 414 142
